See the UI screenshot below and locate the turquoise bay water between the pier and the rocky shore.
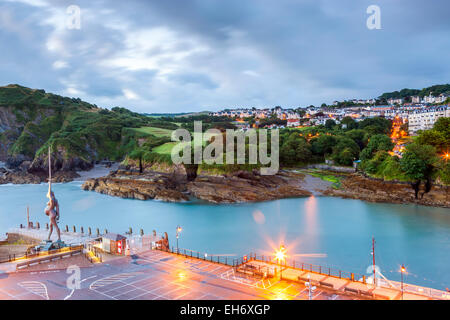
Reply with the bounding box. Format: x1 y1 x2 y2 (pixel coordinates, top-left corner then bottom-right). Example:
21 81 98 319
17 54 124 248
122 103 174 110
0 182 450 289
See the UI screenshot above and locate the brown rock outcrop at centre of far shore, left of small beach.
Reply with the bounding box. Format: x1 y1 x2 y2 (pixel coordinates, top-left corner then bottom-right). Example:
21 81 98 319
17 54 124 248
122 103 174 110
82 171 311 203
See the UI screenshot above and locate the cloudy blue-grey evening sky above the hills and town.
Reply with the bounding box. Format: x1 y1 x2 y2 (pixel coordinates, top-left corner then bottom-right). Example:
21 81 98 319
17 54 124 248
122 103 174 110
0 0 450 113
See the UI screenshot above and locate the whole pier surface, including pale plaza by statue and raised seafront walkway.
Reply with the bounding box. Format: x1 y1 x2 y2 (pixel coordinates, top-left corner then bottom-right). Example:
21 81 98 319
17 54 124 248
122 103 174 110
0 228 450 300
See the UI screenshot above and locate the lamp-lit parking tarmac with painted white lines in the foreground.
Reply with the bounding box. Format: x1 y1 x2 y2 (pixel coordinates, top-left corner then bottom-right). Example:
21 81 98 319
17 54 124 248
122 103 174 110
0 250 446 300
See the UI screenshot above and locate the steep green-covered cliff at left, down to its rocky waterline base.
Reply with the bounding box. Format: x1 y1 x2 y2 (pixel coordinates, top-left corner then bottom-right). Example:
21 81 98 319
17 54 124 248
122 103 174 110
0 85 160 183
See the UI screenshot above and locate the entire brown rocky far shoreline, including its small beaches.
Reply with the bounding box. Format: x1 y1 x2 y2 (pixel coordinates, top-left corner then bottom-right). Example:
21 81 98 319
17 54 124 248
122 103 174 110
0 163 450 208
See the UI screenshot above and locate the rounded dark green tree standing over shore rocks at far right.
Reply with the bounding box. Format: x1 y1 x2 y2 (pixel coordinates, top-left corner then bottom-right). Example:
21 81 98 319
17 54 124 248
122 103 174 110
400 143 438 199
